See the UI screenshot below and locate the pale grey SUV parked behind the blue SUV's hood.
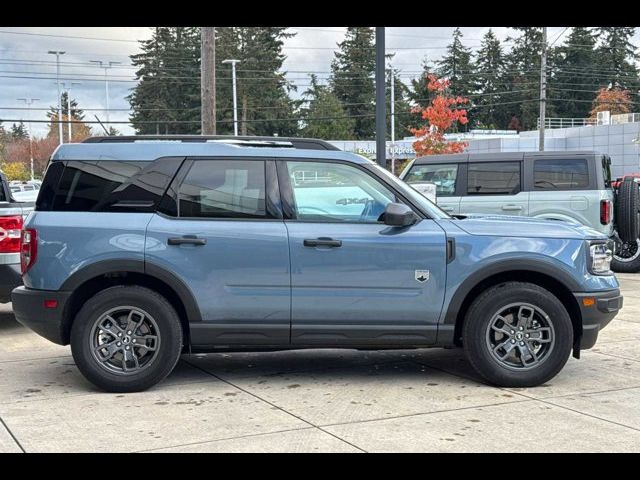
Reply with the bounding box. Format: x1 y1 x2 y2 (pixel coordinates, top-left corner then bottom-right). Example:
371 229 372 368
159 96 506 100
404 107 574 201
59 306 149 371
400 151 640 272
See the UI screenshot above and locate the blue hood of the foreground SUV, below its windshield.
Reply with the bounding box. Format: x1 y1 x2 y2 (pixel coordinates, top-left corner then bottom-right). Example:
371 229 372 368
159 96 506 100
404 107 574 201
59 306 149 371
454 215 607 240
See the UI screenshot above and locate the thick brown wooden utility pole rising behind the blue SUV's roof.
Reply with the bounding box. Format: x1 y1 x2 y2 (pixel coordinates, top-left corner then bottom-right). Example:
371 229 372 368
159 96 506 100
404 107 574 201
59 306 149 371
200 27 216 135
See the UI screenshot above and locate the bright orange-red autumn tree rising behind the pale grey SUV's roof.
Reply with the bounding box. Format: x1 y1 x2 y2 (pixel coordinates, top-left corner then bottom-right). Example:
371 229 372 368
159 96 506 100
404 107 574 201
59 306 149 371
411 74 469 156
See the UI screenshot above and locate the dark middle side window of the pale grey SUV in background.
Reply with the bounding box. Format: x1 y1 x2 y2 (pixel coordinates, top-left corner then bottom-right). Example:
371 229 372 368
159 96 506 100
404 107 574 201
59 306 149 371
467 162 520 195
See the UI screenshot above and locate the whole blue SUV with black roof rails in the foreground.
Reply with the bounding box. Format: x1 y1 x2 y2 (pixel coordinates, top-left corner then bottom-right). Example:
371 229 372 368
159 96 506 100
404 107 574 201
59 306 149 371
12 137 622 392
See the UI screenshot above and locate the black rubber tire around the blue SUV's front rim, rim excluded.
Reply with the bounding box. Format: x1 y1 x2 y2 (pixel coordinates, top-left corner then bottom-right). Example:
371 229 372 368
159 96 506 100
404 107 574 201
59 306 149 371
462 282 573 387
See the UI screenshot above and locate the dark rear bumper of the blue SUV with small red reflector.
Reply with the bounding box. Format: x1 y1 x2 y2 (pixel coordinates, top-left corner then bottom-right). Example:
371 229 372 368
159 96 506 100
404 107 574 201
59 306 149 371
11 287 71 345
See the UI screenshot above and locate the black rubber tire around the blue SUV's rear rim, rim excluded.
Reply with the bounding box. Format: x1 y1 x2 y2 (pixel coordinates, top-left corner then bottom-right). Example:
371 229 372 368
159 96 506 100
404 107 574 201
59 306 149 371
71 285 183 393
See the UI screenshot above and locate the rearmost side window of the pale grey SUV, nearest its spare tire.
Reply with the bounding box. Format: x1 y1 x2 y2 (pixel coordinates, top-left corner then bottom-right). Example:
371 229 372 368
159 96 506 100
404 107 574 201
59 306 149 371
533 158 589 190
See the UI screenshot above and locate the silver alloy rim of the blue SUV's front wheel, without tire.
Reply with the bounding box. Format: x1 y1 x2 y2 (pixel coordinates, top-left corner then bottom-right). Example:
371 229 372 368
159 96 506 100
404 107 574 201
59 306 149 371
486 303 555 371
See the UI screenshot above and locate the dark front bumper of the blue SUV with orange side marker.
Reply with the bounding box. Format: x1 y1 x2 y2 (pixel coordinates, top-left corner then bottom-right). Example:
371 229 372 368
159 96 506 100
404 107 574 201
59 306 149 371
574 289 623 350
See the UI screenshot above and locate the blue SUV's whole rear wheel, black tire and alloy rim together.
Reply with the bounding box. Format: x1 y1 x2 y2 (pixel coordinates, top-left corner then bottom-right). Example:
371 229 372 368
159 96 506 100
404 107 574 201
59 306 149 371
71 286 182 392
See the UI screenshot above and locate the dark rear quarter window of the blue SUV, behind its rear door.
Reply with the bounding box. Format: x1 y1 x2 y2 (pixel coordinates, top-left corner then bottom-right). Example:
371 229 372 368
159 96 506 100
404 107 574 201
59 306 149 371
53 158 182 212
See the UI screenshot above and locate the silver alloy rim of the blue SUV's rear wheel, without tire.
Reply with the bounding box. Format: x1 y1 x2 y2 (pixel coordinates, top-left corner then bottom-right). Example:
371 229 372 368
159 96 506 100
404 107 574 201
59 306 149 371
89 306 160 375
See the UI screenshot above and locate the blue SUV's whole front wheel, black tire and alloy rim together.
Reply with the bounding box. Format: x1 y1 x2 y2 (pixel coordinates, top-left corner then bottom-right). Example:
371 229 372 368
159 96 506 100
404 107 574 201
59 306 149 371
462 282 573 387
